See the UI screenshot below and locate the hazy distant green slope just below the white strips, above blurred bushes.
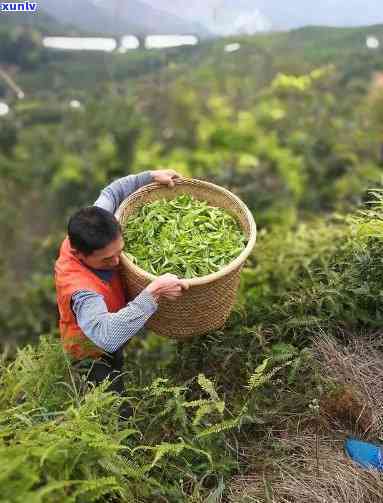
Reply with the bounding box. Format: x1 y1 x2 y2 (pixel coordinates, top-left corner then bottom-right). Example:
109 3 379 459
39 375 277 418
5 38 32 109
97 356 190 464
0 20 383 98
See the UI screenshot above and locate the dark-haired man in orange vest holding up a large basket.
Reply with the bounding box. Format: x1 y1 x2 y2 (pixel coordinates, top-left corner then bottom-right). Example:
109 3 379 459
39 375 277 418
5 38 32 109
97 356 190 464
55 170 188 417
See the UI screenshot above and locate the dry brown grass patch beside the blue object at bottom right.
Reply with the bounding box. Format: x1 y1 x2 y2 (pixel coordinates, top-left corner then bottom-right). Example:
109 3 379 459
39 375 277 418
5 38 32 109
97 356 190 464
227 332 383 503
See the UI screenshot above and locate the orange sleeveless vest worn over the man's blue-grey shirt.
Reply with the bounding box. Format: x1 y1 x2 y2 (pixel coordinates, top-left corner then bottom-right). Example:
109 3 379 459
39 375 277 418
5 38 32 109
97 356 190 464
55 238 126 360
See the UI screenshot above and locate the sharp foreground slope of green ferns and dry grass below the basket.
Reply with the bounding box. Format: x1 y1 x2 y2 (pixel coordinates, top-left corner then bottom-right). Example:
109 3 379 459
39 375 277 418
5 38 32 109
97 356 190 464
0 194 383 503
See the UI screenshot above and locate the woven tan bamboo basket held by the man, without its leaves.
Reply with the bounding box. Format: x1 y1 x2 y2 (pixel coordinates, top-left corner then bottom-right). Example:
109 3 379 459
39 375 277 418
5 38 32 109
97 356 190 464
116 178 256 339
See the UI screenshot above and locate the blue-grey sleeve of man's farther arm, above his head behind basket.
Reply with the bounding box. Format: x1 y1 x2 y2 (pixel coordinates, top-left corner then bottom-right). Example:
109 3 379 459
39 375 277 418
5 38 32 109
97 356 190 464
94 171 153 213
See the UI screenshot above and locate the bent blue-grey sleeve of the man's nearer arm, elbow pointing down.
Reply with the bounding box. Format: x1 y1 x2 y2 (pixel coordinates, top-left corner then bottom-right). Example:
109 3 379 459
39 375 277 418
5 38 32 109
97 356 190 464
72 290 158 353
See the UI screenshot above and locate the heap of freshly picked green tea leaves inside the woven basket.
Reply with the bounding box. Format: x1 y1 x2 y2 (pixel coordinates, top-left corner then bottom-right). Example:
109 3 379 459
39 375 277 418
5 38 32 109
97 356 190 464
123 194 247 278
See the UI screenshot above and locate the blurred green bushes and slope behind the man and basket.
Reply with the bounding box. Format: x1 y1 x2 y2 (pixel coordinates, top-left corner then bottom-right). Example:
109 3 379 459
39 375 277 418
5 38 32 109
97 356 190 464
0 23 382 341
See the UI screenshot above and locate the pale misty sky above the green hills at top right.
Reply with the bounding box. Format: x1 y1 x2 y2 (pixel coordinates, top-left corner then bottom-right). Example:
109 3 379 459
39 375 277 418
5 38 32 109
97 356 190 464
145 0 383 34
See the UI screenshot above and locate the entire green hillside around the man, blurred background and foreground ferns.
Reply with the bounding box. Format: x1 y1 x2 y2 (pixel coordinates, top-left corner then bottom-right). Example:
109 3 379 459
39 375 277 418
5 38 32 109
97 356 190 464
0 21 383 503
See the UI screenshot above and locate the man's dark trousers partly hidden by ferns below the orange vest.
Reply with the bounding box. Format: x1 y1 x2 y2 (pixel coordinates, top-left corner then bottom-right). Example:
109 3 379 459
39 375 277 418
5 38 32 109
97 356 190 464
75 349 132 420
